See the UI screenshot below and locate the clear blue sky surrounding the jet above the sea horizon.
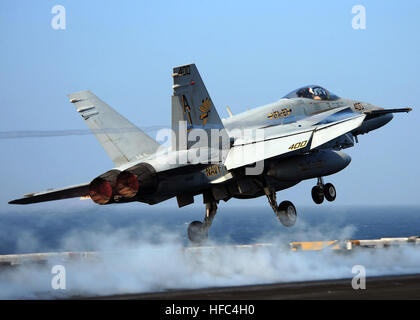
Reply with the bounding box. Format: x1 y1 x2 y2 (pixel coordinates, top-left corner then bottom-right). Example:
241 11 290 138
0 0 420 210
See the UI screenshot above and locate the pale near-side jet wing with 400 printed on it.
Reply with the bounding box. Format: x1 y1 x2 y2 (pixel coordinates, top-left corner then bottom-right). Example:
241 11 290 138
224 109 366 170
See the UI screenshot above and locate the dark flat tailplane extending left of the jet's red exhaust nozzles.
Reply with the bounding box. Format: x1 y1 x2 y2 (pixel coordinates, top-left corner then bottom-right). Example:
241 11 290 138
9 183 89 204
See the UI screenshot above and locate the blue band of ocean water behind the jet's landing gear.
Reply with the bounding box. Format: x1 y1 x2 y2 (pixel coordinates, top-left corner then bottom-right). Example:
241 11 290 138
0 205 420 254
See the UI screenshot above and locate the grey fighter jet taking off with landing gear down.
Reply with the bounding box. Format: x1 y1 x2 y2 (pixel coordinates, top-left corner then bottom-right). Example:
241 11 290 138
9 64 412 243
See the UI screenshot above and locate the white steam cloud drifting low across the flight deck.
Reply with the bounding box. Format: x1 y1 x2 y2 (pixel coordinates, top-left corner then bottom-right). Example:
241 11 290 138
0 220 420 299
